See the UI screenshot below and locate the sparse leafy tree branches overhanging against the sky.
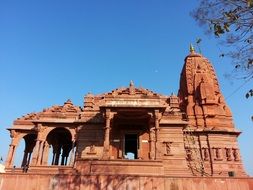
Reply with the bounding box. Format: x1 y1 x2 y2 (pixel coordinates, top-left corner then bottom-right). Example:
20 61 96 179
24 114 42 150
191 0 253 84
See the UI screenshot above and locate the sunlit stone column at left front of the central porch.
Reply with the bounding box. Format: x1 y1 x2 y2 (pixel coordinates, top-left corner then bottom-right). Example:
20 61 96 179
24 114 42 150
103 109 111 159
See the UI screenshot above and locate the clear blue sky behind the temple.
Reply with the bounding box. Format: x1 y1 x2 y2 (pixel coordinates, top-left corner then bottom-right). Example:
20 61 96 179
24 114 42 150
0 0 253 175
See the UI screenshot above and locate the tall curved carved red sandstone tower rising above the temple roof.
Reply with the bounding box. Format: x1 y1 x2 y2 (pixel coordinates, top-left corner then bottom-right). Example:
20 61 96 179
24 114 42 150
178 52 233 130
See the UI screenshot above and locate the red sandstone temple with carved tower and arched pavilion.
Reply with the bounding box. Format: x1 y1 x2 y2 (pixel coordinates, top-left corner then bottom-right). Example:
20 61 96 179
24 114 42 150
0 49 253 189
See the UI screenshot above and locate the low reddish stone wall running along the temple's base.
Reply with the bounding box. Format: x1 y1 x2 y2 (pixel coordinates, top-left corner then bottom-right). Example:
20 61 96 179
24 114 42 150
0 173 253 190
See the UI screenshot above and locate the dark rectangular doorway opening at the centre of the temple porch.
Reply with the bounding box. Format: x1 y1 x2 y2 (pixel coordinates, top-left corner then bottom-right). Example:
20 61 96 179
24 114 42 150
125 134 138 159
